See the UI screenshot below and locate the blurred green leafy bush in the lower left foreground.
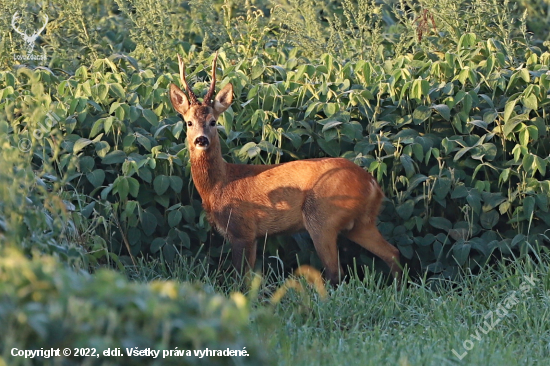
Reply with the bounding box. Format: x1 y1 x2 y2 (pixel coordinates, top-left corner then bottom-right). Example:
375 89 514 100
0 249 273 365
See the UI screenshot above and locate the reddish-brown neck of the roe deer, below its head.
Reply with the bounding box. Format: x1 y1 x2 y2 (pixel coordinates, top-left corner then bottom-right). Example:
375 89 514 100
191 144 227 202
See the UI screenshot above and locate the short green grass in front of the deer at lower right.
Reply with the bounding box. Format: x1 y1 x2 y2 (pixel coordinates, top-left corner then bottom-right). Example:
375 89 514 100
124 250 550 366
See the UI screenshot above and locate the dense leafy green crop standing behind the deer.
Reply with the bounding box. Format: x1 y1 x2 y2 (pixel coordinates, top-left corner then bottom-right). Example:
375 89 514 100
0 0 550 284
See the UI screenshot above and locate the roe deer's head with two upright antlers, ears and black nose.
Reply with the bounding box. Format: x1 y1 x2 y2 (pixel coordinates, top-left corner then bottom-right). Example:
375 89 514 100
170 53 233 154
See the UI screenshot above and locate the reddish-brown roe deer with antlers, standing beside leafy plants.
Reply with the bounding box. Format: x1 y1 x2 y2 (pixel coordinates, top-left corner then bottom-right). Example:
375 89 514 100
170 55 401 284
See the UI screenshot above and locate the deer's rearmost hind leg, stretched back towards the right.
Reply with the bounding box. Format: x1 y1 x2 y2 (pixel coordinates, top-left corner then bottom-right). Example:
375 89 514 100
344 222 402 283
